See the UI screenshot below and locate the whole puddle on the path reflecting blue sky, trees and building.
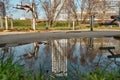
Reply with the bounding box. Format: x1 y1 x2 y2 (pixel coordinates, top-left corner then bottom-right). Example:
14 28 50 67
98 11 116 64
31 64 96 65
0 38 120 76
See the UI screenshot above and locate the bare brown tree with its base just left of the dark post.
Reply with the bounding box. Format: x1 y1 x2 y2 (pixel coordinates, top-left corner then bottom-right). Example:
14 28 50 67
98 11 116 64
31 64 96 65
77 0 100 23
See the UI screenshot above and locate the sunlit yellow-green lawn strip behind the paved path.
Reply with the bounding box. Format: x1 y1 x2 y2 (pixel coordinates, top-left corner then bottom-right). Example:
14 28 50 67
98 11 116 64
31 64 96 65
0 20 120 31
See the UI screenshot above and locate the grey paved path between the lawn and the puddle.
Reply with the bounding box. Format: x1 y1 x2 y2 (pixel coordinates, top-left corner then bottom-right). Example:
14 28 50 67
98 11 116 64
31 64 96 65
0 31 120 46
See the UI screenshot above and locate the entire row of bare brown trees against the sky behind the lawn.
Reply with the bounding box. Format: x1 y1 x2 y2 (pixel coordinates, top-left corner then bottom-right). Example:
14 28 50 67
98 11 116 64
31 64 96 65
0 0 114 28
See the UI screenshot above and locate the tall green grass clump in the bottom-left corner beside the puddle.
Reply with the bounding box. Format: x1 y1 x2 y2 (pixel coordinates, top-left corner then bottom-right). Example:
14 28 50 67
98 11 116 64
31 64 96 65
0 53 24 80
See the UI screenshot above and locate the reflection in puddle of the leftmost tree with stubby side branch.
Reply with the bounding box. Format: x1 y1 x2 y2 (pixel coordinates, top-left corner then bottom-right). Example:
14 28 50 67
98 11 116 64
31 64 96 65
22 41 49 70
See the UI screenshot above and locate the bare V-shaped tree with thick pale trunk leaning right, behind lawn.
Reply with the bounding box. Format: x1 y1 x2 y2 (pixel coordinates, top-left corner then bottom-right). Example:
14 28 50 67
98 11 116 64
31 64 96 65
39 0 65 28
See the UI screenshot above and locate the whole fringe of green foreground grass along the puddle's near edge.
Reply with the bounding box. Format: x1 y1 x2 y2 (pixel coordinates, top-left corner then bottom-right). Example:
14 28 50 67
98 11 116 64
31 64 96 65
0 48 120 80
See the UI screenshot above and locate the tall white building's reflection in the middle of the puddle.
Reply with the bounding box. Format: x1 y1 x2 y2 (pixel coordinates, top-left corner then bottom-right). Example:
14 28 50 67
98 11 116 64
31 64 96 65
52 39 67 76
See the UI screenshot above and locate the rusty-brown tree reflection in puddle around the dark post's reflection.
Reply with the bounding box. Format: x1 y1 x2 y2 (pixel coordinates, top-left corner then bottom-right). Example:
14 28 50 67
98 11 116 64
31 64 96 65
80 38 103 65
